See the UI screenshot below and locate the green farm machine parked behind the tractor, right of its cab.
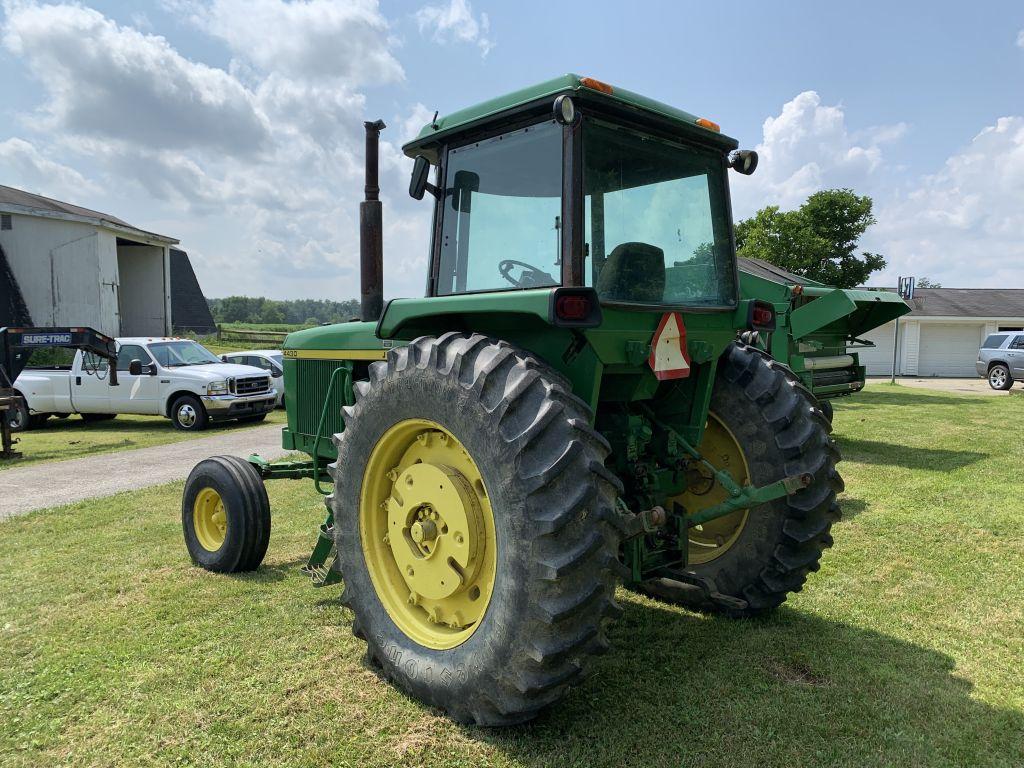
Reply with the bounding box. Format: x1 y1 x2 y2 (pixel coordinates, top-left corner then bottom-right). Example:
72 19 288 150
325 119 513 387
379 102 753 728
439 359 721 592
738 259 910 421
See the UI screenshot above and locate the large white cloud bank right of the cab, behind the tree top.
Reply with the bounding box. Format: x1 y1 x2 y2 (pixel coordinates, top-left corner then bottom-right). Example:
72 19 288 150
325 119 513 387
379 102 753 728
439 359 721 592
730 91 1024 288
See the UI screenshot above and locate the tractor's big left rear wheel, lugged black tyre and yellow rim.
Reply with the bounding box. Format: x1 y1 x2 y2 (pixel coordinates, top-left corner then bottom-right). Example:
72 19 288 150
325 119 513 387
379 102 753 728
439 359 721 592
329 333 622 725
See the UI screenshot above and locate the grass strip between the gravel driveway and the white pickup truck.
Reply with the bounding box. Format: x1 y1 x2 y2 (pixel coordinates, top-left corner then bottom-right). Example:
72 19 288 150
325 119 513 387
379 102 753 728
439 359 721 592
0 409 286 471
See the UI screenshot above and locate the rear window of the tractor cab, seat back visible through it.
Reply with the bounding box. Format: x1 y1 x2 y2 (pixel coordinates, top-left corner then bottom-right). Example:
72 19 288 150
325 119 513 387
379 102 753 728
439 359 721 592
584 120 736 306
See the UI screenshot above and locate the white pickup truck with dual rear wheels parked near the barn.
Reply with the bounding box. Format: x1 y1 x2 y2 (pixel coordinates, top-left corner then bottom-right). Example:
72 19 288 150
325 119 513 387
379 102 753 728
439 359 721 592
9 338 278 431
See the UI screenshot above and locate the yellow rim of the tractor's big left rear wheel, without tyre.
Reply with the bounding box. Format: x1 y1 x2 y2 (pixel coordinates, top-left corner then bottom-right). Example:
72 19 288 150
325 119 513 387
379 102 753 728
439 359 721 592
359 419 498 650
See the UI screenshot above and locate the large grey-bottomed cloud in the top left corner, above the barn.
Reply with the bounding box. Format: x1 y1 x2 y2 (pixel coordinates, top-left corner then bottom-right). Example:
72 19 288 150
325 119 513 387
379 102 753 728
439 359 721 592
3 3 268 156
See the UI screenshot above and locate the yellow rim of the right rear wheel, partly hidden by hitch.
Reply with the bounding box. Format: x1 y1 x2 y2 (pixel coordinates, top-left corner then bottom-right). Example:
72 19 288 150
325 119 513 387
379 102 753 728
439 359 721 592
673 413 751 565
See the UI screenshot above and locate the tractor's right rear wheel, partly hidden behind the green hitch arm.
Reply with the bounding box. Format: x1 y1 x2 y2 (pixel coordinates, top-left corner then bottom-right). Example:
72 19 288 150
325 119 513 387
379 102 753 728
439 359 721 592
641 344 843 615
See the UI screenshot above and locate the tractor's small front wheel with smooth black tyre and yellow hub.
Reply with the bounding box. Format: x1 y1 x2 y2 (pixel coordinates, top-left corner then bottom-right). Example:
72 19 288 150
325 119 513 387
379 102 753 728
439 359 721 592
181 456 270 573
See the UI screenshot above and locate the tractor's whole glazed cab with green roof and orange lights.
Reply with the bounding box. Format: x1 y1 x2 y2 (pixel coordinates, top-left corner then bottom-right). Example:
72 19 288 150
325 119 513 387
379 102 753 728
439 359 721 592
403 75 756 311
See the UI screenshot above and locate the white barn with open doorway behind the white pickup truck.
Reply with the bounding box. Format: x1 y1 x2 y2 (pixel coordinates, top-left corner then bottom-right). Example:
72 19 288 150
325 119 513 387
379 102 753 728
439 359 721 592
0 185 178 336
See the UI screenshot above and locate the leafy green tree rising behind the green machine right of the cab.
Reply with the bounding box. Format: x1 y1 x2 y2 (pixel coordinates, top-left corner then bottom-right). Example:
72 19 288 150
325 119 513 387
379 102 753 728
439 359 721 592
736 189 886 288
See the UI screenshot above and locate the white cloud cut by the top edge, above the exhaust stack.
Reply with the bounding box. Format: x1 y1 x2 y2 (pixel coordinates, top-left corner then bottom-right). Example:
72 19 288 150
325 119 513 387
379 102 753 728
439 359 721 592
169 0 404 87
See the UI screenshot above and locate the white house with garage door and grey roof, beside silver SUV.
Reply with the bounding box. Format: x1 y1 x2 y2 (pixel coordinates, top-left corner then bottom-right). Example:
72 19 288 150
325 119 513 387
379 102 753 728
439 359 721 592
857 288 1024 377
